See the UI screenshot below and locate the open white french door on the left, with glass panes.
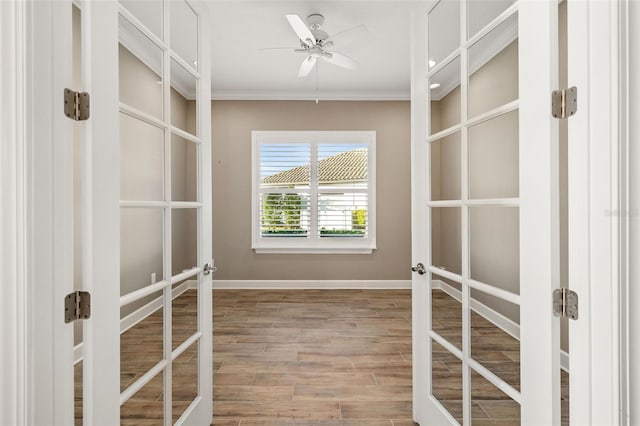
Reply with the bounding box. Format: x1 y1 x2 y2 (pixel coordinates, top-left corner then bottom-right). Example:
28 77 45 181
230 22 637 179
76 0 213 425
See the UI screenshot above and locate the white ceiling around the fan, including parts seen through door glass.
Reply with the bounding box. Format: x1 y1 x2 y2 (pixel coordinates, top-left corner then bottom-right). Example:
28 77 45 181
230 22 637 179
120 0 518 100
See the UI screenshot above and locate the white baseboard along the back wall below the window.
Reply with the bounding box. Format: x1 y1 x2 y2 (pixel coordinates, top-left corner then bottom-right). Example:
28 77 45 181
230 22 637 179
213 280 411 290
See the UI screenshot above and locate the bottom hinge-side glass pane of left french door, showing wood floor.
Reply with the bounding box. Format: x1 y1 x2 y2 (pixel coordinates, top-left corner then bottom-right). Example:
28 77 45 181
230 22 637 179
120 373 164 426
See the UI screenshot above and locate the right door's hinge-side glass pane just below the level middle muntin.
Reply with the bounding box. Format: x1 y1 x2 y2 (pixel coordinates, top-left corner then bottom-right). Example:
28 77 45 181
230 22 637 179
469 206 520 294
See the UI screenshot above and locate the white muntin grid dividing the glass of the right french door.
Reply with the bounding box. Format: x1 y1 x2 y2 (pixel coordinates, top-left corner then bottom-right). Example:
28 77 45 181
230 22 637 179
426 1 521 426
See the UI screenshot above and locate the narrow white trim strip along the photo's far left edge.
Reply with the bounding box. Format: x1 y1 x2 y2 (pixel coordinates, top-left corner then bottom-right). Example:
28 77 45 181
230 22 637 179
0 2 30 425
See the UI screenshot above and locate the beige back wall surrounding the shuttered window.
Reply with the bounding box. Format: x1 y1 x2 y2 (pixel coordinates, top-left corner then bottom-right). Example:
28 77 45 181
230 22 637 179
212 101 411 280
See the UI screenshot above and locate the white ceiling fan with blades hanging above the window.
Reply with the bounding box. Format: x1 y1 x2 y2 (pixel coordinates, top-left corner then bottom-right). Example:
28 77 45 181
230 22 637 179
263 13 367 77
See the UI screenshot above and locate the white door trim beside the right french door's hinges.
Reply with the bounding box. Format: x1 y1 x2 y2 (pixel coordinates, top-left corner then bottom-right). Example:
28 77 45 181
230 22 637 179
568 1 624 424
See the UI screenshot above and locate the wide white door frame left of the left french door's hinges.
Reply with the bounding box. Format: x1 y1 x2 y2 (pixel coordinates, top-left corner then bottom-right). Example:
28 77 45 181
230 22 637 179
0 0 73 424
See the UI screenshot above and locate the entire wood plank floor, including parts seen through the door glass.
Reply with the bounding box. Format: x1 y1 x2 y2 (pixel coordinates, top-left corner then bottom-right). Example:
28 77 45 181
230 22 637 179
76 290 568 426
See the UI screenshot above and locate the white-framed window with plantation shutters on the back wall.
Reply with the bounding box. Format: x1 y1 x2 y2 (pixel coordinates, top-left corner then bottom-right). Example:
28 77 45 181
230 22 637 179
252 131 376 253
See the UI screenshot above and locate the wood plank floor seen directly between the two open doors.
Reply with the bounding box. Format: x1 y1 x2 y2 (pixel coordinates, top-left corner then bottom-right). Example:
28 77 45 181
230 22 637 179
213 290 413 426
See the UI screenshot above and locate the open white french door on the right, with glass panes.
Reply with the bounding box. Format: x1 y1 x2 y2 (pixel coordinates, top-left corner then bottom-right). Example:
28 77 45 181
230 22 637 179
412 0 561 425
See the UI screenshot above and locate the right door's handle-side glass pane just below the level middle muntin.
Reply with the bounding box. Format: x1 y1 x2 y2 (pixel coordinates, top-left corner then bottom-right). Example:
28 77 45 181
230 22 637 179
431 207 462 275
